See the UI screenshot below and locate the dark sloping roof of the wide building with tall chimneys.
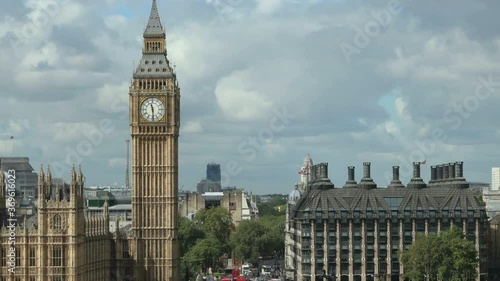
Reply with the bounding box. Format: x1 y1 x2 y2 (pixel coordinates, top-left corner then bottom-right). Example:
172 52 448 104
292 162 484 218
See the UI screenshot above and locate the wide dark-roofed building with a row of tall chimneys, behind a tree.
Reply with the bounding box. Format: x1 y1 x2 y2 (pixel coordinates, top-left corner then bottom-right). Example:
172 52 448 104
285 162 488 281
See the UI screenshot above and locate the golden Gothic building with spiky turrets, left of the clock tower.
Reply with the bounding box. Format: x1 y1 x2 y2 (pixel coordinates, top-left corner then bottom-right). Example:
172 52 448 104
0 166 113 281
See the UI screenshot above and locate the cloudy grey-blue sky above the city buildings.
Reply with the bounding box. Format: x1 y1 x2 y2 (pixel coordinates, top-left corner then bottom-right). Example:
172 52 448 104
0 0 500 194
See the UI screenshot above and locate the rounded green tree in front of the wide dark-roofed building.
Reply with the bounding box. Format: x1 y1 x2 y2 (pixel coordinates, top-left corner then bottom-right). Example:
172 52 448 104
401 227 479 281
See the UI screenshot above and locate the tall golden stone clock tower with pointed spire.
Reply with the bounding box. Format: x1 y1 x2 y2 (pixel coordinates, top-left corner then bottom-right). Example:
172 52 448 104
129 0 180 281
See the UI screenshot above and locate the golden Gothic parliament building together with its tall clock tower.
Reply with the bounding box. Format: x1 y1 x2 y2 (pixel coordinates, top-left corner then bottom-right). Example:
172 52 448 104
0 0 180 281
